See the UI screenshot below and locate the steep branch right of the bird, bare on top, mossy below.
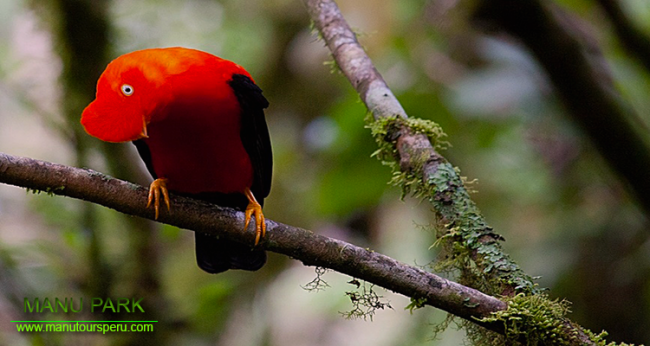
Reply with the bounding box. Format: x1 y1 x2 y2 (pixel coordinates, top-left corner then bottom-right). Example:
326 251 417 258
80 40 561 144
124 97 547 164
303 0 636 345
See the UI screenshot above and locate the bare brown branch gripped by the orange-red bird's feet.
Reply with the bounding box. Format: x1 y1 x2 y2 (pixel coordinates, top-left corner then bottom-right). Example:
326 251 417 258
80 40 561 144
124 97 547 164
0 153 506 332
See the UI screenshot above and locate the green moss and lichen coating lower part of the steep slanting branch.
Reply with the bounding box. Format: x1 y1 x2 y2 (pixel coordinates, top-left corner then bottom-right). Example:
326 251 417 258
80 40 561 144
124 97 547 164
367 116 636 346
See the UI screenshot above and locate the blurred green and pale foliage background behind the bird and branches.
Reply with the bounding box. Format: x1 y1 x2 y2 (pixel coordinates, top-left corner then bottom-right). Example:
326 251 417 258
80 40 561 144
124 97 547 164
0 0 650 345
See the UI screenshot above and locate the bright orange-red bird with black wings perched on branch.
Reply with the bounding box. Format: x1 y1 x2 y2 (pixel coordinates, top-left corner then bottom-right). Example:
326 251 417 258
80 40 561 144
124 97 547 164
81 48 273 273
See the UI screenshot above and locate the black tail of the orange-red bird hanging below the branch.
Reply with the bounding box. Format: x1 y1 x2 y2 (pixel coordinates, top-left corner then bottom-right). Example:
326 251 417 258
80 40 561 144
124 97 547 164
195 232 266 274
